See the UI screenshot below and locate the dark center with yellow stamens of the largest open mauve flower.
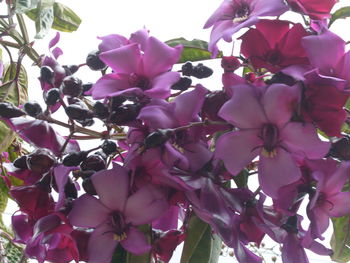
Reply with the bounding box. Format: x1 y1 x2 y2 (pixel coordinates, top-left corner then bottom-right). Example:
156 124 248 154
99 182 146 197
259 123 279 158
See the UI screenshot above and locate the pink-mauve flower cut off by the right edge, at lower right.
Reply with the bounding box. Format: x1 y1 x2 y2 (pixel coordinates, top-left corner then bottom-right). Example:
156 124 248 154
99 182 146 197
307 159 350 238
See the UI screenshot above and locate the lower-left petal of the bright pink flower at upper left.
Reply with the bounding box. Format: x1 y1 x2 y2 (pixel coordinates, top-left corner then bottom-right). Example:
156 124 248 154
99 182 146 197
91 74 130 100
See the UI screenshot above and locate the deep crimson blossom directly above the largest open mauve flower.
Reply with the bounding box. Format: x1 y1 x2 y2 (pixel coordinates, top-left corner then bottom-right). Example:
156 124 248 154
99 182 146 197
240 19 309 73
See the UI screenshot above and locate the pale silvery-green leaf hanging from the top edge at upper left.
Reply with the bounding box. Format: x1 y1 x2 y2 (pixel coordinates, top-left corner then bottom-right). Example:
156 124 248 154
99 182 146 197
35 0 55 39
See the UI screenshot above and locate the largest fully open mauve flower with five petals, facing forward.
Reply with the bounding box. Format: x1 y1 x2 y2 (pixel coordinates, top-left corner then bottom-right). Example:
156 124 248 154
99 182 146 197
215 84 330 198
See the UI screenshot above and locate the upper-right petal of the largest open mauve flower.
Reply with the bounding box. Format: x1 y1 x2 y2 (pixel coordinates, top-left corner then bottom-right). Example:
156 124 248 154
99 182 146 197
262 84 300 126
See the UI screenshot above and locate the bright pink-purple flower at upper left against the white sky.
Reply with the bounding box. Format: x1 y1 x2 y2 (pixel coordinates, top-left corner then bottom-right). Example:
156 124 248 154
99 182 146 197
91 31 182 99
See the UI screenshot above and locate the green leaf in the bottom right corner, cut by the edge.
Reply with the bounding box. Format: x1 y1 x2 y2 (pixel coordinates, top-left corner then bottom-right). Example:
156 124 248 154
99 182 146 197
331 216 350 263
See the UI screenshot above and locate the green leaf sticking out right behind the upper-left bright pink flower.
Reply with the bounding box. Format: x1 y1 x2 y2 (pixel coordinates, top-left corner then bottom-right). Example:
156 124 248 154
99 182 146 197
165 37 222 63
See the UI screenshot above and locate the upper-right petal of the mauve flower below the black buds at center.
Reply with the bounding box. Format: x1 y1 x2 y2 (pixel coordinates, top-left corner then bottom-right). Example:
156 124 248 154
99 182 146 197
173 84 208 126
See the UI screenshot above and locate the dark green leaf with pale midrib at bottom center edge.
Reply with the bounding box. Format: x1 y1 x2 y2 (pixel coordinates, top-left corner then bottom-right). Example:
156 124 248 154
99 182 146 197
180 215 222 263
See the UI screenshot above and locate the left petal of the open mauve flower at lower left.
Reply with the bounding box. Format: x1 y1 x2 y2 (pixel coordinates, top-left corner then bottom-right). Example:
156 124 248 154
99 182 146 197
68 194 111 227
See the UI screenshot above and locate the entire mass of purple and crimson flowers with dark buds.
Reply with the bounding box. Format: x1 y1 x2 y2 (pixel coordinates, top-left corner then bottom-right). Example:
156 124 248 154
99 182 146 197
0 0 350 263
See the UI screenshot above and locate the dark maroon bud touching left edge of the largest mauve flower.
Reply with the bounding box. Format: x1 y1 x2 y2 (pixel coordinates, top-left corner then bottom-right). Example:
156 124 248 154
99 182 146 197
202 91 228 120
